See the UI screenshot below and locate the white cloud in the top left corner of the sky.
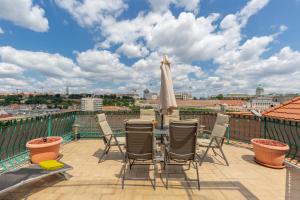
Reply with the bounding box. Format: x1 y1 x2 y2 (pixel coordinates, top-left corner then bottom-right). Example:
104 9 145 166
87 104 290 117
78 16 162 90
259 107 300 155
0 0 49 32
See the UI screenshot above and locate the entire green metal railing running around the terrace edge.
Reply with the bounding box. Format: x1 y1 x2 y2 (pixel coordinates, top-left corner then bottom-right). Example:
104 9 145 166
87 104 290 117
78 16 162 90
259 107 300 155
0 111 300 171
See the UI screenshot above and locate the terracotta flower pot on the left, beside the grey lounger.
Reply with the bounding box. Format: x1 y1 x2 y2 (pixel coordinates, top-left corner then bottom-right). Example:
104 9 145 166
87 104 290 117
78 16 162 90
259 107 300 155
26 136 63 163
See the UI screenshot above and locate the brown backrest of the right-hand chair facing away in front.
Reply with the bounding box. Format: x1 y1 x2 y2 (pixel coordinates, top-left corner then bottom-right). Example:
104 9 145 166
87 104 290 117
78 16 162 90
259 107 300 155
169 119 198 160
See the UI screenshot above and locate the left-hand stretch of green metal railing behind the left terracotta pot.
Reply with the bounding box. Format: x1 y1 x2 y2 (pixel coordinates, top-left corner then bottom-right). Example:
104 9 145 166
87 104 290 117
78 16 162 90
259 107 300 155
0 112 76 171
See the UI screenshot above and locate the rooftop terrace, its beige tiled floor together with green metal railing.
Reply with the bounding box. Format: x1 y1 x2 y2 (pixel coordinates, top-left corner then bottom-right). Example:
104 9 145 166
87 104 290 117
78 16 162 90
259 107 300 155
0 112 300 199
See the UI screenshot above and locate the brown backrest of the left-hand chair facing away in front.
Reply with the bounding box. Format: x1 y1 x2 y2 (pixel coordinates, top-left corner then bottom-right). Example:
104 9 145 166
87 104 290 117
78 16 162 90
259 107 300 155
125 119 155 160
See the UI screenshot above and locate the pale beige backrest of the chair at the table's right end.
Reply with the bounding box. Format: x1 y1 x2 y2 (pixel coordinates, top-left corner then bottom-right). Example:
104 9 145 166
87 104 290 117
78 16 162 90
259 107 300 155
211 113 229 138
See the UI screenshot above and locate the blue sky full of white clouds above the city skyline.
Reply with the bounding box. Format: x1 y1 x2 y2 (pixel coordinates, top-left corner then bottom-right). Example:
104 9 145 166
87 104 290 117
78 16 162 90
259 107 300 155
0 0 300 96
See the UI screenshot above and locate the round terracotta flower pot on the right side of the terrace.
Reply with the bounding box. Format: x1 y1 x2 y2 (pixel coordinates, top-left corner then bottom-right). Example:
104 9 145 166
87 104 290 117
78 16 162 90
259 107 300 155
251 138 289 168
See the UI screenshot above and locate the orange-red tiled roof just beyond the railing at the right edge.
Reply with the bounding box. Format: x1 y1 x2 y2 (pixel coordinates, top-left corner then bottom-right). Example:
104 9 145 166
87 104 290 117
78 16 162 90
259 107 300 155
262 97 300 121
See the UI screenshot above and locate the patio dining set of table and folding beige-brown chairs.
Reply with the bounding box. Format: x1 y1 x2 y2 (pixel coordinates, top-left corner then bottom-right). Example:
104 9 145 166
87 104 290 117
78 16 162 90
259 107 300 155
97 109 229 189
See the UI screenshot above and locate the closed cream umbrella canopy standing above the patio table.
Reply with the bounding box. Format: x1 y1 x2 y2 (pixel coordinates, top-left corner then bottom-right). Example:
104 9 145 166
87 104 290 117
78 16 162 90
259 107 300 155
159 56 177 114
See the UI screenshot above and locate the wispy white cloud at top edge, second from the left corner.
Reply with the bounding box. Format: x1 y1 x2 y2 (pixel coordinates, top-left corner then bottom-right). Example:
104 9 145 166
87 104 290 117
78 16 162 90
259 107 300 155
55 0 127 27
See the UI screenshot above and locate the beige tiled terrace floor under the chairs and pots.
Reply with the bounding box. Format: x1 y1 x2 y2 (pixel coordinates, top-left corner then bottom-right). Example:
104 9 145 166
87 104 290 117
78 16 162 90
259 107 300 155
0 140 300 200
